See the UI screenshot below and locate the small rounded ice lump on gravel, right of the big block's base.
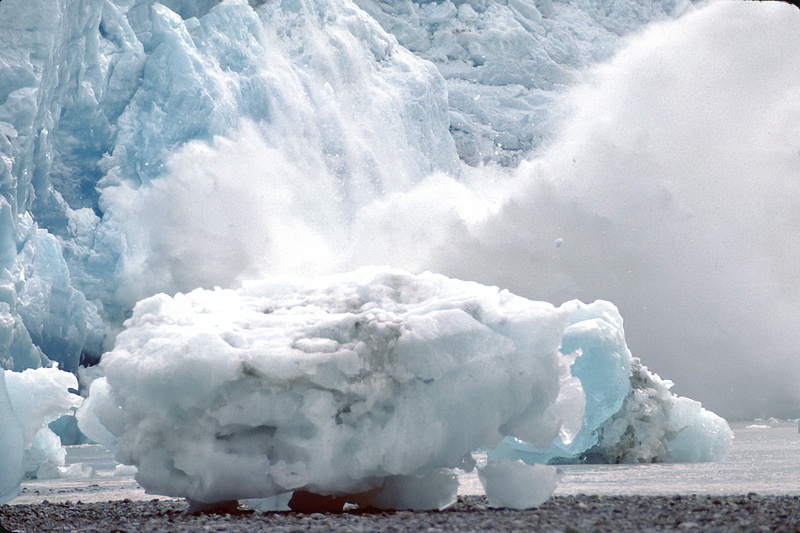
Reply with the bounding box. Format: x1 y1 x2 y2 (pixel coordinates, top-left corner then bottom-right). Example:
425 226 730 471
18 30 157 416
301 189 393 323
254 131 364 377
478 459 561 509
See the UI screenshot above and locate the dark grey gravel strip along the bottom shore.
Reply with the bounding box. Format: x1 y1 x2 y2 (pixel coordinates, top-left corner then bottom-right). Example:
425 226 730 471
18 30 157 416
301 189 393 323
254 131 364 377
0 493 800 533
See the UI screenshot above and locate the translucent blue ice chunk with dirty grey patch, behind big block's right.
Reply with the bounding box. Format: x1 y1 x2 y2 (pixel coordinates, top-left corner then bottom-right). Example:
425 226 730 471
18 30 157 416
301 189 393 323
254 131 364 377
489 301 733 463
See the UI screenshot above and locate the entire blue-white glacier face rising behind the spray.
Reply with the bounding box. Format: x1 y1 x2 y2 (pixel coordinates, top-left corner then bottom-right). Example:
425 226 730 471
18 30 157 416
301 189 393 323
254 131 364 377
0 0 692 376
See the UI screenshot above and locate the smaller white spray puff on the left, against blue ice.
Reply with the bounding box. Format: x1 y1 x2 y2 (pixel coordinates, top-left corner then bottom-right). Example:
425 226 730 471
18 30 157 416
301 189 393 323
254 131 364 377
103 123 343 304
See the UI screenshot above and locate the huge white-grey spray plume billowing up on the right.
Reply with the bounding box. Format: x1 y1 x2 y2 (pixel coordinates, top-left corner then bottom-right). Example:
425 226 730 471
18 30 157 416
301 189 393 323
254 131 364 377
428 2 800 416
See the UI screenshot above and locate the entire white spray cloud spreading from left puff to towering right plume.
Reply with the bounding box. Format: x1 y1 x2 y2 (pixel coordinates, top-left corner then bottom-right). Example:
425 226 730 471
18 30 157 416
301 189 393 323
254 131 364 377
104 2 800 417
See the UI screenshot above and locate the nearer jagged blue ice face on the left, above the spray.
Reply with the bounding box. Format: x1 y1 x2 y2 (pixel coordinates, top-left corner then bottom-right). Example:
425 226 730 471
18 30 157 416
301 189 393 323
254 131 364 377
0 0 457 370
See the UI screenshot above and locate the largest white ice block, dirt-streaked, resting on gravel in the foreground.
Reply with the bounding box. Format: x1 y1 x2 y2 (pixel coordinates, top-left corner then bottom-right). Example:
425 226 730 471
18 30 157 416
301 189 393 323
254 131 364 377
79 268 582 509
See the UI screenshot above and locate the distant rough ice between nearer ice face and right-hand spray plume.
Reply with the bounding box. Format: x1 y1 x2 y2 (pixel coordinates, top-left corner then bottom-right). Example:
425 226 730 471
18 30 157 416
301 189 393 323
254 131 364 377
356 0 690 165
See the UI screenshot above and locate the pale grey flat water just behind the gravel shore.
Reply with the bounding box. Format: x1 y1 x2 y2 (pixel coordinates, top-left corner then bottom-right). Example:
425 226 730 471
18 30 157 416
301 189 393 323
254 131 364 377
10 420 800 504
